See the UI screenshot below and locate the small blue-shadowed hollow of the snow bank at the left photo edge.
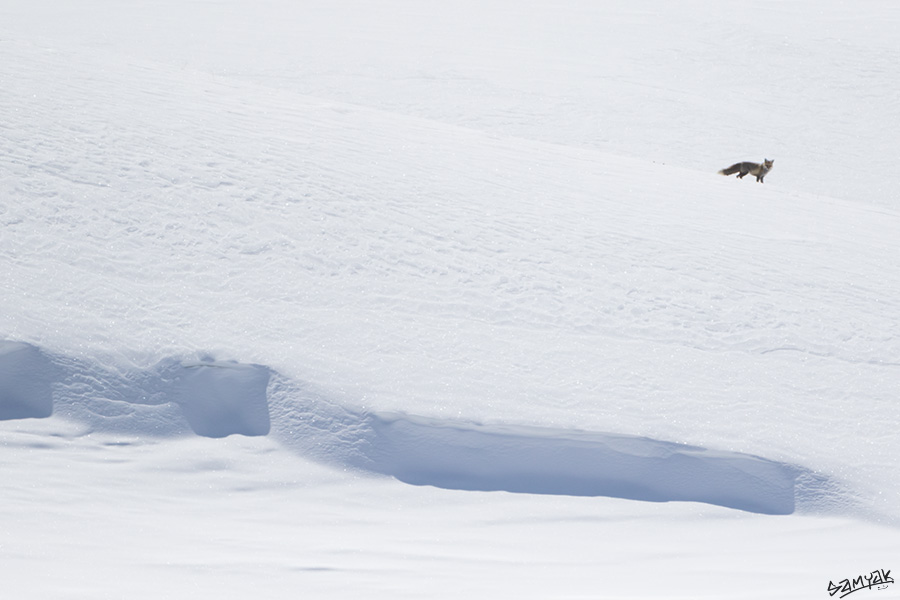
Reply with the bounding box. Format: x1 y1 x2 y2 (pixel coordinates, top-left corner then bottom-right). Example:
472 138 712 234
0 340 56 420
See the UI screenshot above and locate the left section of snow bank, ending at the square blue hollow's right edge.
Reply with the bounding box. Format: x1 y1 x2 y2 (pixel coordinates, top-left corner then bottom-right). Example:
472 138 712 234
0 340 270 438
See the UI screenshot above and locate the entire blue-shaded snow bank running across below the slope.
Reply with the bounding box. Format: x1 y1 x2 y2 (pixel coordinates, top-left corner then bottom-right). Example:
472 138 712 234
0 341 833 515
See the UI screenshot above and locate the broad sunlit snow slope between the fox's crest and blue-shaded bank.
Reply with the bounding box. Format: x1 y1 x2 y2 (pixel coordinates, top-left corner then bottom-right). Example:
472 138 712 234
4 37 900 512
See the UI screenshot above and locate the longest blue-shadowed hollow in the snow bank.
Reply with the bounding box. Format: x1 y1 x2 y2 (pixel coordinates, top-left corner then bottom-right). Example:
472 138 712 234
358 415 798 514
